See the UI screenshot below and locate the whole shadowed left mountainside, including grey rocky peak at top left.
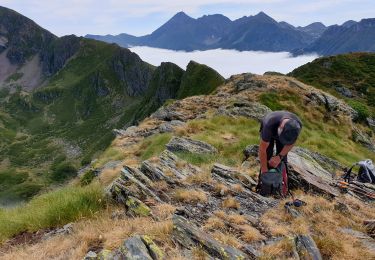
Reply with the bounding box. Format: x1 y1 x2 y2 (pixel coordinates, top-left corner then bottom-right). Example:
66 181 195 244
0 8 224 204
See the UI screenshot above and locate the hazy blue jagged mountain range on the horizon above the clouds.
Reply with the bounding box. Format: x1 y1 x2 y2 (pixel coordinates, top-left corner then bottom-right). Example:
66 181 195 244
85 12 375 56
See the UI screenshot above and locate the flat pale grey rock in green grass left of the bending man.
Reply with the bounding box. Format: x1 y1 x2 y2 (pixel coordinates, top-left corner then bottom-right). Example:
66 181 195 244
166 137 218 154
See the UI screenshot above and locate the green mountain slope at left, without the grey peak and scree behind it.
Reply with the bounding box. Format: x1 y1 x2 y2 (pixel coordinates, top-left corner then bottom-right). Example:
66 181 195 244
0 42 223 203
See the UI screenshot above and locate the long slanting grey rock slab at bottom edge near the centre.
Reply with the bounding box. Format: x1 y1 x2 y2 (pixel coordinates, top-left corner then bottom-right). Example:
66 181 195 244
172 214 248 259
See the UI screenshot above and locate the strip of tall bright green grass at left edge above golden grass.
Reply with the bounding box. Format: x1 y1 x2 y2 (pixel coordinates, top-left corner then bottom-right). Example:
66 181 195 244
0 184 104 241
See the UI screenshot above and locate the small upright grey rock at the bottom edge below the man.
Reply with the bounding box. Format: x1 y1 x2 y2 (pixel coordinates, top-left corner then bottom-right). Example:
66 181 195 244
295 235 323 260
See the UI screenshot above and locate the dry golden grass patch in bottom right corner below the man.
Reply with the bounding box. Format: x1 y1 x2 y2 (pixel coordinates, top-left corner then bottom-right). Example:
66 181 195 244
261 192 375 259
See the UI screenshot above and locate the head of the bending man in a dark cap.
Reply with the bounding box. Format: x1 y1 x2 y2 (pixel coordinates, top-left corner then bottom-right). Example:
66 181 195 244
277 118 301 145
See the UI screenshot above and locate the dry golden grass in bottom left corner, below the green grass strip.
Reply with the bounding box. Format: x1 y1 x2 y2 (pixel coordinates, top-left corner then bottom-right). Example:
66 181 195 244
0 209 179 260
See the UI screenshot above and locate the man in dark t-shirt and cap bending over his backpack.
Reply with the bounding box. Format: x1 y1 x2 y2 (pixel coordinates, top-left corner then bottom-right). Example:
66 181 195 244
259 111 302 195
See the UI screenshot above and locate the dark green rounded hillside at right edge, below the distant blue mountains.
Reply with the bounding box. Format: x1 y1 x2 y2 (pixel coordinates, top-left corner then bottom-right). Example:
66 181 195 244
289 53 375 113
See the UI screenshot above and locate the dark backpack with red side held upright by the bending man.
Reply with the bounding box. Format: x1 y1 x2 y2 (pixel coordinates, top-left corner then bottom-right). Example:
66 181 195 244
257 162 288 197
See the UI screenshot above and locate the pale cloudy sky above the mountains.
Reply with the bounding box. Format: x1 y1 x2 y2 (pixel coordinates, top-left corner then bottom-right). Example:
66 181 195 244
0 0 375 36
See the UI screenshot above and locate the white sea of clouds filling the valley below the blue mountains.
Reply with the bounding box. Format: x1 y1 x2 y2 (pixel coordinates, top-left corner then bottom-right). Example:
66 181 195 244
130 46 318 78
